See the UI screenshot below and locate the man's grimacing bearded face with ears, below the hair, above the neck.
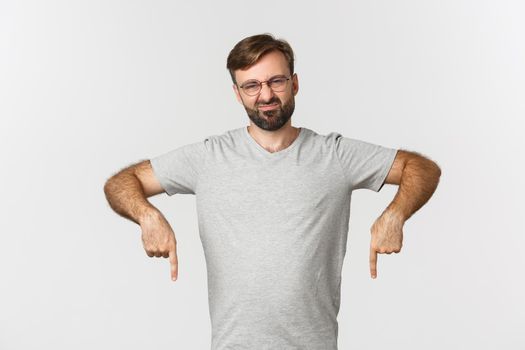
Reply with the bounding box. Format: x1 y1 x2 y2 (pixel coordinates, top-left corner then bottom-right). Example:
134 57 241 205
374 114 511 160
233 51 299 131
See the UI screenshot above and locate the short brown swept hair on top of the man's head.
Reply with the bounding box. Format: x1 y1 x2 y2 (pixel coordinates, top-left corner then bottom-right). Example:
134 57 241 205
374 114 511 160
226 33 294 84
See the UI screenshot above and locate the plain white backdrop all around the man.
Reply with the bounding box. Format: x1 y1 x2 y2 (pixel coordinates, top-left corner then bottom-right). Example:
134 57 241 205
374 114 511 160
0 0 525 350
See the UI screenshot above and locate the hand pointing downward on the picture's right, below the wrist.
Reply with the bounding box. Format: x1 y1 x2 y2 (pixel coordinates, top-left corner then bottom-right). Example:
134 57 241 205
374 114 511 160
370 210 405 278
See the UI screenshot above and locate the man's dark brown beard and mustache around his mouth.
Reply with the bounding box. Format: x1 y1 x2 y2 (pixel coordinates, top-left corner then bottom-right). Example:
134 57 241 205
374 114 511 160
244 96 295 131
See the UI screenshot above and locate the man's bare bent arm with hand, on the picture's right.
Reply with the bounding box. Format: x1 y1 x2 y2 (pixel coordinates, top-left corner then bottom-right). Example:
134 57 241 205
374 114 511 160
370 150 441 278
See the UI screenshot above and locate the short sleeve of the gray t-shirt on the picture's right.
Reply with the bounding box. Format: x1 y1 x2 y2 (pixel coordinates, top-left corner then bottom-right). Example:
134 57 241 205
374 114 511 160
334 133 397 192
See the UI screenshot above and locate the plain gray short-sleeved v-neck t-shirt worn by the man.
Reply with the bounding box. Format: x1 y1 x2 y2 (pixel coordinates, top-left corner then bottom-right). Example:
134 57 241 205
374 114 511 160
151 126 397 350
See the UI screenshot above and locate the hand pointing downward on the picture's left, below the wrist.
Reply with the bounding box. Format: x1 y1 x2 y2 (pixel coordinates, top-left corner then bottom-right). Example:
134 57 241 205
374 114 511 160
140 210 179 281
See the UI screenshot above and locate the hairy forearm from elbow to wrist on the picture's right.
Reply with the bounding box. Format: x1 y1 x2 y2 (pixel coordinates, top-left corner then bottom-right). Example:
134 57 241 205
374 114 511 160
385 157 441 221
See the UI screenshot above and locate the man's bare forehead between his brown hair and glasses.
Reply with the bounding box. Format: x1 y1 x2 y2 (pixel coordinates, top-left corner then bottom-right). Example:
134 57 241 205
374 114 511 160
235 51 290 83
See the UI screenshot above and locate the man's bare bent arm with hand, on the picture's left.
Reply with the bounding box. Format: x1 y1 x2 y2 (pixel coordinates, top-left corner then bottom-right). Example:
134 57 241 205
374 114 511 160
104 160 178 281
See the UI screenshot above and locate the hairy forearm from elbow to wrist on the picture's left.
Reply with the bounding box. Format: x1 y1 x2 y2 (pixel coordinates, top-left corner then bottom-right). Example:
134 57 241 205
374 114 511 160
104 169 159 225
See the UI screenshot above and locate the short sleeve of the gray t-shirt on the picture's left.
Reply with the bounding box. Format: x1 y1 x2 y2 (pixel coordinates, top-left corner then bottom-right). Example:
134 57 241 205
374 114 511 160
150 139 208 196
